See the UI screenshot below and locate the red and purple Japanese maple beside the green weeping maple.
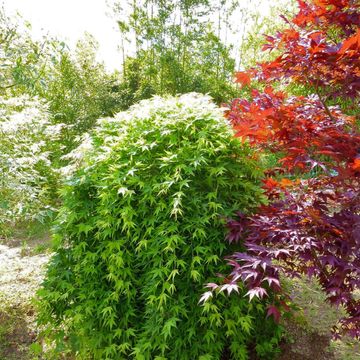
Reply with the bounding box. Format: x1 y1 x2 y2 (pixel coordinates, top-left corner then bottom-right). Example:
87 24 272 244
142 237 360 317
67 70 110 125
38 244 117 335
209 0 360 337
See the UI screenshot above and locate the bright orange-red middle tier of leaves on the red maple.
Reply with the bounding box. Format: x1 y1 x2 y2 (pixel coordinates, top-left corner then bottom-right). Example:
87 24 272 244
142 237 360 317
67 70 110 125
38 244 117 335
226 87 360 174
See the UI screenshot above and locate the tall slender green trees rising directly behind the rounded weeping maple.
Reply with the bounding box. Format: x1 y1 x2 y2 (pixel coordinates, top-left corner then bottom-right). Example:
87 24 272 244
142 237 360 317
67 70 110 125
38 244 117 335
114 1 236 108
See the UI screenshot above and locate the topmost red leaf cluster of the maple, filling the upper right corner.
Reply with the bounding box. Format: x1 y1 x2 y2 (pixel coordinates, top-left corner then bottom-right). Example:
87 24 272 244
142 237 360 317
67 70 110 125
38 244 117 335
251 0 360 100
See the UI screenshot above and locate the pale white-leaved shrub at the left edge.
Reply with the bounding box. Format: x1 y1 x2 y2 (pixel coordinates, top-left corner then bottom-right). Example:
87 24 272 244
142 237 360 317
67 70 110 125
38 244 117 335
0 96 62 235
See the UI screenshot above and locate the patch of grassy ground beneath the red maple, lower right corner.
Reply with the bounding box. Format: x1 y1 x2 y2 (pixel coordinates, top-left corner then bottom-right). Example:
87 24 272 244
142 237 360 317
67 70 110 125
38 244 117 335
280 278 360 360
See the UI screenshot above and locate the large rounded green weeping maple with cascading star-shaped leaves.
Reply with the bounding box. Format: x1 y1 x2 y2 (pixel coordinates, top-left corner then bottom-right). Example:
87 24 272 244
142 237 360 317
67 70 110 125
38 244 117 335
39 94 280 360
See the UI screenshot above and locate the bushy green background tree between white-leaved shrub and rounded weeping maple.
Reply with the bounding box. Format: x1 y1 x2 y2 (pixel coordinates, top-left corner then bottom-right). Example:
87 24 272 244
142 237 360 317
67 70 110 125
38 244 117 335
39 34 121 153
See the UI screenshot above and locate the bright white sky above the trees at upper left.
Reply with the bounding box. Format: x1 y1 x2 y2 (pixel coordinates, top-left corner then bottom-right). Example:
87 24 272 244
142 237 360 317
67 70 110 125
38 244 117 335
0 0 121 70
